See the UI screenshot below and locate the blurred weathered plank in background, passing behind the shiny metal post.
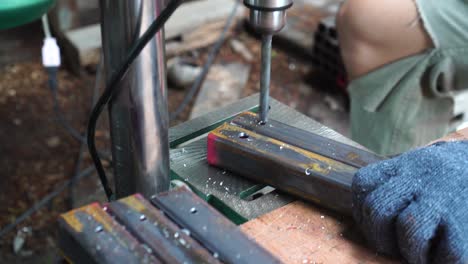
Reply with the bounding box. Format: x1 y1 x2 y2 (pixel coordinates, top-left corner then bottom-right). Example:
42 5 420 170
64 0 245 66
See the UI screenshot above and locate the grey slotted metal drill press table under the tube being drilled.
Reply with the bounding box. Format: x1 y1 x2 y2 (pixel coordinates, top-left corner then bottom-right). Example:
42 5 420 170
169 94 362 224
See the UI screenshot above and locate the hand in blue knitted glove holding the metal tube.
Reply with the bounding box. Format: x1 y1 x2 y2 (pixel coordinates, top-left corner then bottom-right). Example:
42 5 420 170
353 141 468 263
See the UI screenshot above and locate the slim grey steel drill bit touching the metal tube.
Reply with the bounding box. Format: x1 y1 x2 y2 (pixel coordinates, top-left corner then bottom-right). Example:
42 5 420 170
260 35 273 124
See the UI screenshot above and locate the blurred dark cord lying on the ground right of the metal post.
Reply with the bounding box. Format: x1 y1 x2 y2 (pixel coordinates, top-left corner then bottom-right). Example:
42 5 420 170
170 1 239 121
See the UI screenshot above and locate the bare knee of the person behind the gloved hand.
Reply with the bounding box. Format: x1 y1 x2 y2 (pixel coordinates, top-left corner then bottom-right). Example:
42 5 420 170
337 0 433 80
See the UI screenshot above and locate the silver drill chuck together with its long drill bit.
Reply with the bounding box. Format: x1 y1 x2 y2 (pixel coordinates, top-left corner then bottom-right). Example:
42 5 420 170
244 0 293 123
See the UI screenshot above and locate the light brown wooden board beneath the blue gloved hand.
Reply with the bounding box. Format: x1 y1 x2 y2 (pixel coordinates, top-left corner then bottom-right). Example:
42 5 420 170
241 129 468 263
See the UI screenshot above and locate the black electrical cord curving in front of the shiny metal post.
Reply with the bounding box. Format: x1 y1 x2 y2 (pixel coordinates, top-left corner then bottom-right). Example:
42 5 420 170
87 0 183 200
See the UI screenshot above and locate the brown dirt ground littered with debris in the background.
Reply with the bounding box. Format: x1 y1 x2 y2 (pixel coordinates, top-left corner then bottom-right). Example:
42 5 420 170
0 21 349 263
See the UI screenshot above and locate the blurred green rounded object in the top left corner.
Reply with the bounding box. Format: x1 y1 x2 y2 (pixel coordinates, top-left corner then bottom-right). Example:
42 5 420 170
0 0 55 30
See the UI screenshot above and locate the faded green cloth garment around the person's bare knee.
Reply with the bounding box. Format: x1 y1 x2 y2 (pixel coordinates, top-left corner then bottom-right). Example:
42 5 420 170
349 0 468 155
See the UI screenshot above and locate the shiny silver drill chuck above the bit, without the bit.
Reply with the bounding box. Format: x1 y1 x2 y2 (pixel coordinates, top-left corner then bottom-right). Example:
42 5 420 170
244 0 293 35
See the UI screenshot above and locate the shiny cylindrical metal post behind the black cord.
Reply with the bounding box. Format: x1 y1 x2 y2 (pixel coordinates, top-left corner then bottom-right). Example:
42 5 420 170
100 0 169 198
